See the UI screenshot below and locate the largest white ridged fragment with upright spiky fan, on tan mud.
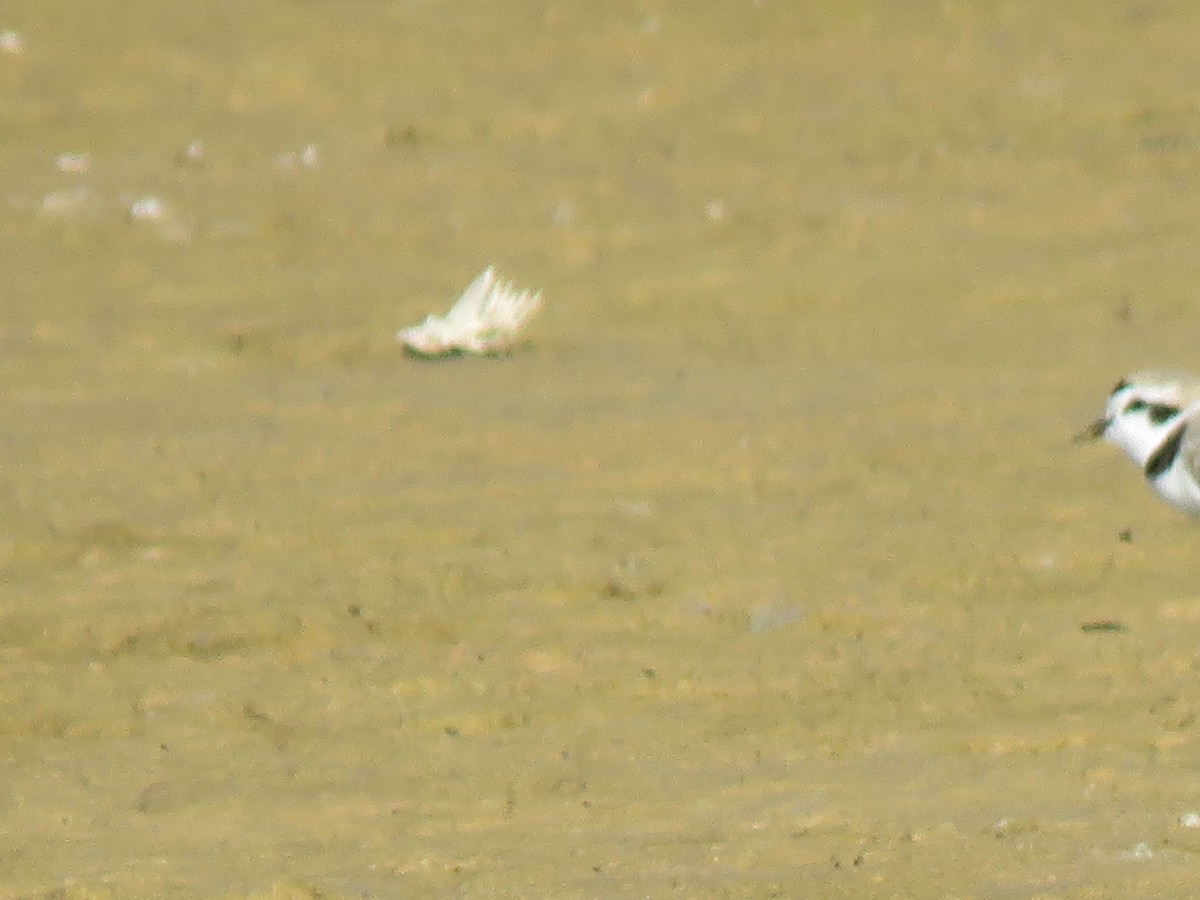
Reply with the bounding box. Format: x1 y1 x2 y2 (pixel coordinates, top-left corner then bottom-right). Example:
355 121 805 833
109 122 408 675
396 266 541 358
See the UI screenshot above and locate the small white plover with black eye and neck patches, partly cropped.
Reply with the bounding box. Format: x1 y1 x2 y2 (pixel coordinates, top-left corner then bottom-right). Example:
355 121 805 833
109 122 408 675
1078 372 1200 517
